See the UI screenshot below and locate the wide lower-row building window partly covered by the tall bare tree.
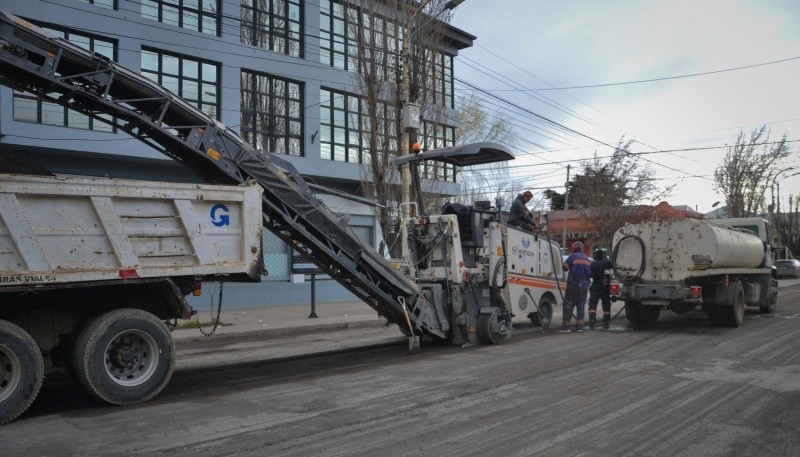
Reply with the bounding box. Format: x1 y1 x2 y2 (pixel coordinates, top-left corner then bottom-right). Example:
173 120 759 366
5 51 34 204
319 89 398 163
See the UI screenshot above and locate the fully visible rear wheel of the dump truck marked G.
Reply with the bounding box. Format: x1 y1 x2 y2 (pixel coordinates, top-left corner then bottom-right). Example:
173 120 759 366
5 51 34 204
72 308 175 405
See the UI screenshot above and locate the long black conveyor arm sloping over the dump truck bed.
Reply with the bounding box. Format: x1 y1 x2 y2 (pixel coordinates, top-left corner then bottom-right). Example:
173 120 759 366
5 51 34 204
0 13 446 338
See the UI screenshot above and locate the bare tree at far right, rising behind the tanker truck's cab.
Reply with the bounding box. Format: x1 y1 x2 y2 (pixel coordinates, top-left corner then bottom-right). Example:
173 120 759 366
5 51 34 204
714 125 791 217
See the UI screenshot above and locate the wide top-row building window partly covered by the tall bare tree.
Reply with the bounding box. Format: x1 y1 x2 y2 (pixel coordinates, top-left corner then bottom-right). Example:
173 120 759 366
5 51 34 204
319 0 402 79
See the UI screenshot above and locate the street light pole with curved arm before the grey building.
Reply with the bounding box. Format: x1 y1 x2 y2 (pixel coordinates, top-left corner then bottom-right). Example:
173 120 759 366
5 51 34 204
399 0 466 207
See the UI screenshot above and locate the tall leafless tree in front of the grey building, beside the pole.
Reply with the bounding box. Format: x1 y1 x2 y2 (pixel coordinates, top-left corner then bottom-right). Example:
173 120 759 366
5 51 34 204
341 0 460 239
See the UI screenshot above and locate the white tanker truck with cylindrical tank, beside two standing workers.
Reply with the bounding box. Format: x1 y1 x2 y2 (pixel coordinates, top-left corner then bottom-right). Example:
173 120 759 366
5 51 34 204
611 217 778 327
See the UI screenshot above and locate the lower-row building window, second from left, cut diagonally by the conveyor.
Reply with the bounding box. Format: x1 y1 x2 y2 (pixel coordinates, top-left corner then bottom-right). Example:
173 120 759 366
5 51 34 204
142 49 219 117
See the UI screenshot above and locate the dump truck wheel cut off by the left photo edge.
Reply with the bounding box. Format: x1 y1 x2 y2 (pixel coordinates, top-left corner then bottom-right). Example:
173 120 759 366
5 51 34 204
0 320 44 424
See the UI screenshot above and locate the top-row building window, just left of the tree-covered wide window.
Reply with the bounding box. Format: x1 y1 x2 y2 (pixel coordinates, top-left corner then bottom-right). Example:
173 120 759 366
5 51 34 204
241 0 303 57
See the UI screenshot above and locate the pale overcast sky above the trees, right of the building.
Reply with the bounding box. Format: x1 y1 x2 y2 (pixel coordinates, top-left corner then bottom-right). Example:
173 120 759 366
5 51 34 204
452 0 800 212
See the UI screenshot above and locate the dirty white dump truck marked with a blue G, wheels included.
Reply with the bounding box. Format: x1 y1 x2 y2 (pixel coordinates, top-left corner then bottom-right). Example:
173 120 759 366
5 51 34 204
0 174 263 423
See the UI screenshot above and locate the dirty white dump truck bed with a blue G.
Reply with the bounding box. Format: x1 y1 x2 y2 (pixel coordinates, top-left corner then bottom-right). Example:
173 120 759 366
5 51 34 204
0 174 262 287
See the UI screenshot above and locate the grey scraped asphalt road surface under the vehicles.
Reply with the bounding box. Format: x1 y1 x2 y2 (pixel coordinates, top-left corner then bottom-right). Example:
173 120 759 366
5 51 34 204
0 286 800 457
